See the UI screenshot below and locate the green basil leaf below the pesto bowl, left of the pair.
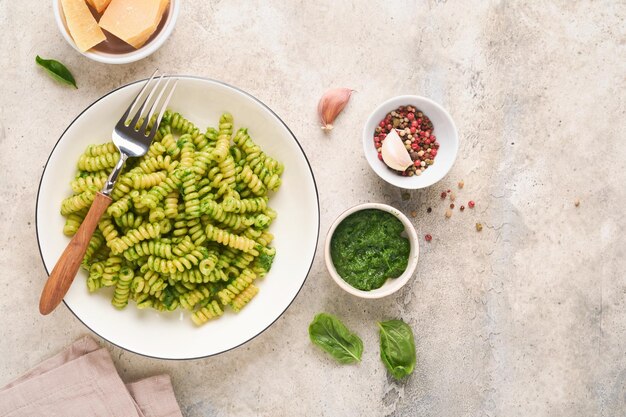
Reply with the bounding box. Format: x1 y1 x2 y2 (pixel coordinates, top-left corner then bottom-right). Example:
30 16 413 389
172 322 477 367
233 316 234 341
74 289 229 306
309 313 363 363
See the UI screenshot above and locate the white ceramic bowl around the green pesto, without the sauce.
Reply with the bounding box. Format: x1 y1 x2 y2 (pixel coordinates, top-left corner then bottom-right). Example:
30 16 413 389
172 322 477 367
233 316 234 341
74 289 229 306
324 203 419 298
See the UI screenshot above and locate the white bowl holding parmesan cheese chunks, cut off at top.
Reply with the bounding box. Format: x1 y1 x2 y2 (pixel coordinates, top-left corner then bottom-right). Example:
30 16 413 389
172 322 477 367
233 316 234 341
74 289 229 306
52 0 181 64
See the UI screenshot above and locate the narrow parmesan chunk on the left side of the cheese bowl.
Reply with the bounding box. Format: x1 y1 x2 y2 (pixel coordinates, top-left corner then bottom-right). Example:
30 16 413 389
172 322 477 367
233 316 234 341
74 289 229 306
61 0 106 52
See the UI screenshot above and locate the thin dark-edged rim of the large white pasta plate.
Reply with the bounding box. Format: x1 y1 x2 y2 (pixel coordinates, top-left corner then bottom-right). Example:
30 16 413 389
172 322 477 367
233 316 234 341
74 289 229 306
35 75 321 361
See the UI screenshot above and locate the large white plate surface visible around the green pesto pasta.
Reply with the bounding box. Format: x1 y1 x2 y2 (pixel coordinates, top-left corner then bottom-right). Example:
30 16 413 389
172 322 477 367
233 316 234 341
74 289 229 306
36 76 320 359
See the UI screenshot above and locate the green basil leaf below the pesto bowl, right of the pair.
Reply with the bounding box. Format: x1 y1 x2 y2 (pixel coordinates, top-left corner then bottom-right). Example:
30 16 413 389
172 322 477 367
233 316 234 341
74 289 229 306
378 320 416 379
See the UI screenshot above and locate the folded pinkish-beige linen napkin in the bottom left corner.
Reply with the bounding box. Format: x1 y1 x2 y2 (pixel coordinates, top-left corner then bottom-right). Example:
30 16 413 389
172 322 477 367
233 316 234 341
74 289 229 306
0 336 182 417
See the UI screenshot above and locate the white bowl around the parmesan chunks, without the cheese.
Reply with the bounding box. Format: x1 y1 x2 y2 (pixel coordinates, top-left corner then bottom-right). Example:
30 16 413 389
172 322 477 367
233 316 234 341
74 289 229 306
52 0 181 64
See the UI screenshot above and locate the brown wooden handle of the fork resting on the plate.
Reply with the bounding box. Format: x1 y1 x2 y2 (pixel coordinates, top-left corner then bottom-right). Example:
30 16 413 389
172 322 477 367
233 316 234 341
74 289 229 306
39 192 111 315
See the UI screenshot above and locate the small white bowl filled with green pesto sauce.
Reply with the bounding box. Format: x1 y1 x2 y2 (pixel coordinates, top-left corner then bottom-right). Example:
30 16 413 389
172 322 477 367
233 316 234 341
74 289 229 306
324 203 419 298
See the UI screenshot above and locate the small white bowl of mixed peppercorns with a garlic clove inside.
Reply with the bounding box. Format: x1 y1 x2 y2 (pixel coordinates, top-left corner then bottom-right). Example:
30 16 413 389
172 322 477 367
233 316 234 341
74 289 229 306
363 95 459 189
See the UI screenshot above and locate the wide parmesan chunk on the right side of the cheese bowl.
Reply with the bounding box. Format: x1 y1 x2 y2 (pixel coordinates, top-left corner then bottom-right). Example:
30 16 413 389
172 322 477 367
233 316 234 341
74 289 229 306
99 0 169 48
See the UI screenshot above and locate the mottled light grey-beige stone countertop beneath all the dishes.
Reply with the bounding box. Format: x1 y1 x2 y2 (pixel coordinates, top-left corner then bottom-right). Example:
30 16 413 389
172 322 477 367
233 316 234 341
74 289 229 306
0 0 626 417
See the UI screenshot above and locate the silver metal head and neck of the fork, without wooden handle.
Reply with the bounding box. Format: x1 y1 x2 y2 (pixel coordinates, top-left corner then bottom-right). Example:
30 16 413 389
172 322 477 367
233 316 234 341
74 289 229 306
102 71 178 196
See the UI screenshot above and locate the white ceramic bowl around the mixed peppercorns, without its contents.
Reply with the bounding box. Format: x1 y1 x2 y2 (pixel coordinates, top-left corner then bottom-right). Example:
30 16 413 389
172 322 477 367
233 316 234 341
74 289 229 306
363 95 459 189
